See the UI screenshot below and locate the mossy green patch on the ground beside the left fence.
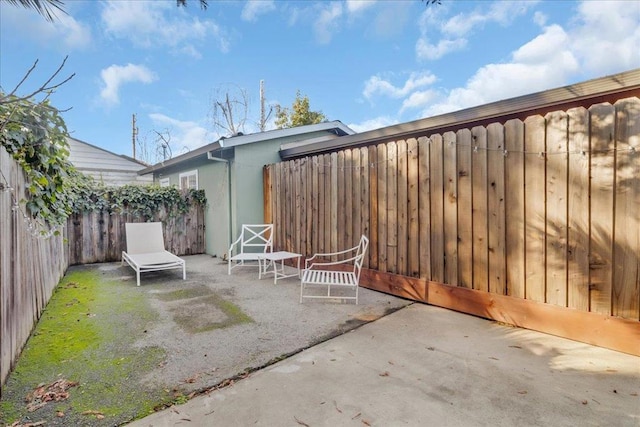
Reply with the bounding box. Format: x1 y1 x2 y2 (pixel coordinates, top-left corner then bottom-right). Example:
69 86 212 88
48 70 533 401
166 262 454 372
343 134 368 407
0 267 171 426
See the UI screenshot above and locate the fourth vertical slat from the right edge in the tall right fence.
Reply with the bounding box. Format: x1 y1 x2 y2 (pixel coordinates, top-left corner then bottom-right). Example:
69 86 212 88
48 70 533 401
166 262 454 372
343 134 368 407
545 111 569 307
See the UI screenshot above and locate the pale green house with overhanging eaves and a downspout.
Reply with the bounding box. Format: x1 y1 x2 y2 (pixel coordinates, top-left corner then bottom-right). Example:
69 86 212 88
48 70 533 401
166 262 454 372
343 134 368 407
139 121 355 258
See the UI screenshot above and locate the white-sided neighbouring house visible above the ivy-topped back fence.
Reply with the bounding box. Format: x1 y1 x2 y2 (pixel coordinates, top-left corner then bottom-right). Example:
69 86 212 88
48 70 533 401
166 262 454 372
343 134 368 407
67 137 153 186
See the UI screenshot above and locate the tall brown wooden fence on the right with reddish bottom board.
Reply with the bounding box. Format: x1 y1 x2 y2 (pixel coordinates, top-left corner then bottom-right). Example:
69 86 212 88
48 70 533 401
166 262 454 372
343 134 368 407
265 98 640 355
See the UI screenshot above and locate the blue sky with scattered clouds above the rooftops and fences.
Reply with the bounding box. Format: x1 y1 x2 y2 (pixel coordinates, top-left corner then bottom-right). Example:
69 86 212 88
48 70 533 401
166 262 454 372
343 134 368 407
0 0 640 162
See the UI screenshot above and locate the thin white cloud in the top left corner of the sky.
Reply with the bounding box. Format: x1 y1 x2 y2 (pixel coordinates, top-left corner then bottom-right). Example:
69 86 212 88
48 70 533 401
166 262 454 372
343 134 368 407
0 7 92 53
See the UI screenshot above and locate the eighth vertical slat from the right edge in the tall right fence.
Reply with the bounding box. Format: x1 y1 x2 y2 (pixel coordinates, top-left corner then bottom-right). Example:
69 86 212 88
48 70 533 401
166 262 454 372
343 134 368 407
471 126 489 292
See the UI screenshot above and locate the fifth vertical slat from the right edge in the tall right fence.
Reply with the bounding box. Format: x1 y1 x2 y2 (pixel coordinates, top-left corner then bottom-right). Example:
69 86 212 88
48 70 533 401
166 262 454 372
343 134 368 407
524 116 546 302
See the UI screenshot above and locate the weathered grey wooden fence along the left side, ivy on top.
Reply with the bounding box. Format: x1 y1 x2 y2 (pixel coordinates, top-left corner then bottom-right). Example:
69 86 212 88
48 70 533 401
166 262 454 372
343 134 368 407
0 148 68 384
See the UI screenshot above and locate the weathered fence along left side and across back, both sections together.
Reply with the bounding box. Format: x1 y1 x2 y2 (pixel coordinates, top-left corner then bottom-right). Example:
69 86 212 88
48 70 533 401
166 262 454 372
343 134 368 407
0 148 205 385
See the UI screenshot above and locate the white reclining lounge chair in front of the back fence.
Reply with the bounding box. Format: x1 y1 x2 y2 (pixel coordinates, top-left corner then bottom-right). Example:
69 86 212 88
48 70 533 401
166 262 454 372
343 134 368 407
122 222 187 286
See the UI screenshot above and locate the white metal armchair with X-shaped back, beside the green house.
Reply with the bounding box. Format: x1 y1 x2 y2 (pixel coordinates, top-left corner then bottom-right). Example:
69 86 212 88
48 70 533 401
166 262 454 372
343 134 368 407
228 224 273 274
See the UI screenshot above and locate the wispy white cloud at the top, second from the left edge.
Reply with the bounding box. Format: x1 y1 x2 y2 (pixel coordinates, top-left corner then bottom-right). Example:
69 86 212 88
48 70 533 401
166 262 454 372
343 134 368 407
102 0 229 56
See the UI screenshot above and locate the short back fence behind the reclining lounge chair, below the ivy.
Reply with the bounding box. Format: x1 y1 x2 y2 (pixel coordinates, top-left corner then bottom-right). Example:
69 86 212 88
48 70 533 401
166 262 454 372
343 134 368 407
67 206 205 265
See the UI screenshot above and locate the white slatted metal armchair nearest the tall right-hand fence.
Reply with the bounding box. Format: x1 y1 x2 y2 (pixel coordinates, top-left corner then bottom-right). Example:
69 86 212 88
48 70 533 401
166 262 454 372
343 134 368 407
300 235 369 304
